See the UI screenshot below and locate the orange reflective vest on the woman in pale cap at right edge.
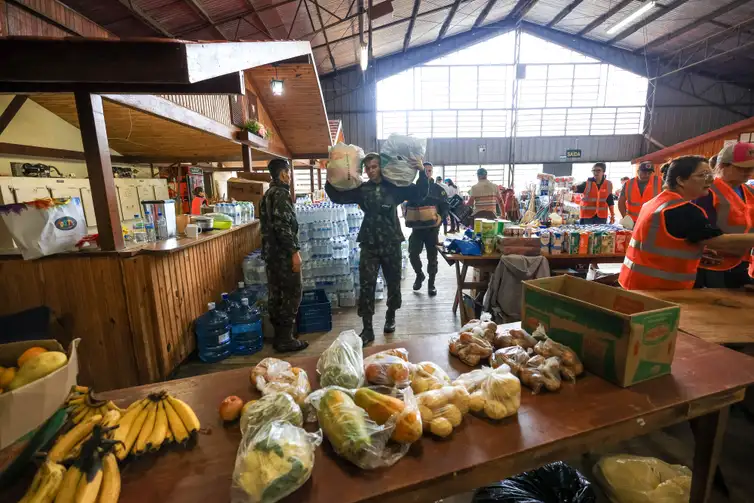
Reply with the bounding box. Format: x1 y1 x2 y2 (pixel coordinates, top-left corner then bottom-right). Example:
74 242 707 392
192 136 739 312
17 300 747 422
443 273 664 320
704 178 754 271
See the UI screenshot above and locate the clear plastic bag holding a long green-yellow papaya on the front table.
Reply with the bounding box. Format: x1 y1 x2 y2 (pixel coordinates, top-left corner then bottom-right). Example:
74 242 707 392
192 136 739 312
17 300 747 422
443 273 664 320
311 388 409 470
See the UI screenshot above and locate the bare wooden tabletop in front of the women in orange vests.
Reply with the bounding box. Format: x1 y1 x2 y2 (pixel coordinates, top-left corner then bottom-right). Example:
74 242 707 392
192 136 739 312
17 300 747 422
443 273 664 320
637 288 754 344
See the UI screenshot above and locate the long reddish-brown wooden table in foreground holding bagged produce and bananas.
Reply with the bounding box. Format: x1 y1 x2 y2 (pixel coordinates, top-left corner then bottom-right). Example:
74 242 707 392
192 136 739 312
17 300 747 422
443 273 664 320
6 333 740 503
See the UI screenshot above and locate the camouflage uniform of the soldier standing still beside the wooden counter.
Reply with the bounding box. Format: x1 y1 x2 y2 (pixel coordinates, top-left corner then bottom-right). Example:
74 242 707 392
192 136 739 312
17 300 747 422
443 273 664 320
259 180 301 333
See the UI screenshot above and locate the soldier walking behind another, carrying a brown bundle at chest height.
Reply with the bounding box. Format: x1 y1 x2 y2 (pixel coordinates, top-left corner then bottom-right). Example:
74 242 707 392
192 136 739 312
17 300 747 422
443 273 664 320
406 162 450 297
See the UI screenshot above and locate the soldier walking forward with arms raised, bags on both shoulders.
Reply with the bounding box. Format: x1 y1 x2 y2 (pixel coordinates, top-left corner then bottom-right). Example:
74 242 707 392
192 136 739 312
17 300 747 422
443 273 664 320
325 153 428 345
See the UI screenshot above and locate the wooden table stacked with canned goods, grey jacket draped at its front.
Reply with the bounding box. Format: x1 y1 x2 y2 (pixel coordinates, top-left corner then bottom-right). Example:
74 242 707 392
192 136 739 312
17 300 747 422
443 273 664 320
437 245 626 314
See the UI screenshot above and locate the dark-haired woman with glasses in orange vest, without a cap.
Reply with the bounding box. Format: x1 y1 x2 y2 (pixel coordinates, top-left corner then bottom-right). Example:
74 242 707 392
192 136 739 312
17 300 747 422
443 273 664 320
618 155 754 290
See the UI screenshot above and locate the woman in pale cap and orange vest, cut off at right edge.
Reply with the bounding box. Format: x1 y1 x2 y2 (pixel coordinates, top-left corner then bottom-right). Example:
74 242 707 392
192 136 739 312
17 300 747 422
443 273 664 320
694 142 754 288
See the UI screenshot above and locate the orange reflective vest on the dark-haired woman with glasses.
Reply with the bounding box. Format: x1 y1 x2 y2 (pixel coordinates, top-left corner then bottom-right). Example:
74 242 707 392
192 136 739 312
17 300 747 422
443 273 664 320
618 190 706 290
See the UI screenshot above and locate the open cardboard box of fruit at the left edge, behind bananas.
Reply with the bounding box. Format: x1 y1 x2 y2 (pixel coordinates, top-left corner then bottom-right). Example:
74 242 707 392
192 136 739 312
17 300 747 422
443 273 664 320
0 339 81 449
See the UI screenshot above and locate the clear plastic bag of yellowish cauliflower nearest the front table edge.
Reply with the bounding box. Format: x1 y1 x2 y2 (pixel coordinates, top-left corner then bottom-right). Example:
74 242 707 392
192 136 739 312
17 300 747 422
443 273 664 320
231 421 322 503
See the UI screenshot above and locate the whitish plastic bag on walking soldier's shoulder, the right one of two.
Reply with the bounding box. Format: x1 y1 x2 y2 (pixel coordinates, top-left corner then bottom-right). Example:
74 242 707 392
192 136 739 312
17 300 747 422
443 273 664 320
380 134 427 187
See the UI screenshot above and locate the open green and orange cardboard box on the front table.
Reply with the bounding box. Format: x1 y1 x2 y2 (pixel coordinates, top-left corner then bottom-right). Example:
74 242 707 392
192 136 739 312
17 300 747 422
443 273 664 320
521 276 681 387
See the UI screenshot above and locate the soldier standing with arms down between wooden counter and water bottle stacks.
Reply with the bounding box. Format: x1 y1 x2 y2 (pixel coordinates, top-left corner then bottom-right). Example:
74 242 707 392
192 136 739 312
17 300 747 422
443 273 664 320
259 159 309 353
